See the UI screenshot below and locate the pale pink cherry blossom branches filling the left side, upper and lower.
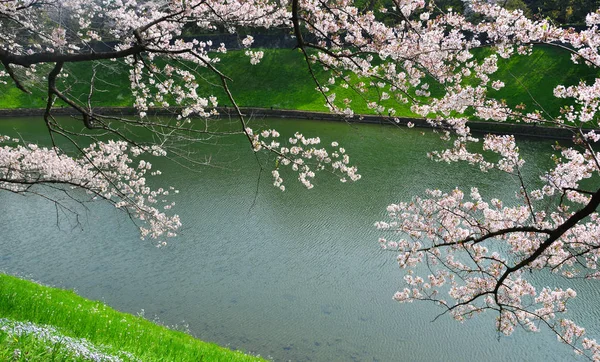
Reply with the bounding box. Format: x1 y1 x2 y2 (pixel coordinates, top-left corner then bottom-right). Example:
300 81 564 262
0 0 360 243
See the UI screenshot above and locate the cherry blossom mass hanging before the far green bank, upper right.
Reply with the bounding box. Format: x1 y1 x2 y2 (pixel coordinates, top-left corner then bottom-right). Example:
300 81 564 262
300 0 600 131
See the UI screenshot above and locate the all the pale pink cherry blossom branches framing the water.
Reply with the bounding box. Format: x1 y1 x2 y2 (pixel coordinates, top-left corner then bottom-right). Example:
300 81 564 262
0 0 600 360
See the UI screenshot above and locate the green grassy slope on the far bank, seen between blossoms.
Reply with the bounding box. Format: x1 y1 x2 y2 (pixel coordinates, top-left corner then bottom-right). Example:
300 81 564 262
0 46 598 117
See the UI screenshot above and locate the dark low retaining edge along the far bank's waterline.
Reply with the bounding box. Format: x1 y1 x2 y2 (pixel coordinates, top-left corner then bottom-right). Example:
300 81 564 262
0 107 591 139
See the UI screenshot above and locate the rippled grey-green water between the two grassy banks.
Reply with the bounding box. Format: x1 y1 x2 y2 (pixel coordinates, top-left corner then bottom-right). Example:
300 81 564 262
0 119 600 361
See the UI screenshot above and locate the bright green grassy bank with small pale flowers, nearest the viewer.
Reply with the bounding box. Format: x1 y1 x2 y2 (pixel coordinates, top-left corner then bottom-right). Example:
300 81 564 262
0 274 261 362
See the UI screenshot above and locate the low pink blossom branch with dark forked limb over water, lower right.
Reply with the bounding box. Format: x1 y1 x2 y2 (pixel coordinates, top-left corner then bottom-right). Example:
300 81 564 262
376 182 600 358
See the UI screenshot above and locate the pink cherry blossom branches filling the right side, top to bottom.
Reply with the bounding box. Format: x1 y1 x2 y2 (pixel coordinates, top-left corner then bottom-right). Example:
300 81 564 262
292 0 600 360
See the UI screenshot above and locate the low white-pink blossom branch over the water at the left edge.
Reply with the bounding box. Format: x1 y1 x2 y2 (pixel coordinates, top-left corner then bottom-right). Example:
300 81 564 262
0 136 181 243
